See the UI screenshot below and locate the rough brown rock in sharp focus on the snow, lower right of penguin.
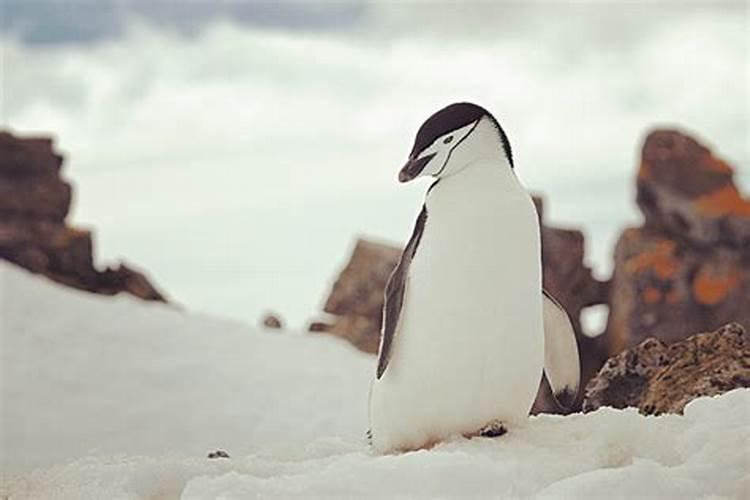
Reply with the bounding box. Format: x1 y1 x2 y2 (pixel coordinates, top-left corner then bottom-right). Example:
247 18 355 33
583 323 750 415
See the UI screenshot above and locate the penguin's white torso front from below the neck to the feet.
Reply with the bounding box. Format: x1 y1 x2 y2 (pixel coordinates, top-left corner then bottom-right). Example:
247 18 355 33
370 169 544 451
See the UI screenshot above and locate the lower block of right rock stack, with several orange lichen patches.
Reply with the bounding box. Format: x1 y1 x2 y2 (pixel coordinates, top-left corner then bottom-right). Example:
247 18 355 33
607 228 750 355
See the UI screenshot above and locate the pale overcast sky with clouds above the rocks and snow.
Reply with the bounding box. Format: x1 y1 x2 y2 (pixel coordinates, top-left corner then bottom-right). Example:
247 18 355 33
0 0 750 323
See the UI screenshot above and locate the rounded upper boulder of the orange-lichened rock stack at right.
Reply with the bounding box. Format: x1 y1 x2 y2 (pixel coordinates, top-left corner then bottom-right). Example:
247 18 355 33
637 130 750 249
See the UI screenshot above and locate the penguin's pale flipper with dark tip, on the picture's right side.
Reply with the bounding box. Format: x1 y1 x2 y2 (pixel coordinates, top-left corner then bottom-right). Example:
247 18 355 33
542 289 581 409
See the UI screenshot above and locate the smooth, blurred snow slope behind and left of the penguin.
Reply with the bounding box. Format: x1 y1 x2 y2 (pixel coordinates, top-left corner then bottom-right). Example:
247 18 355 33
0 261 374 471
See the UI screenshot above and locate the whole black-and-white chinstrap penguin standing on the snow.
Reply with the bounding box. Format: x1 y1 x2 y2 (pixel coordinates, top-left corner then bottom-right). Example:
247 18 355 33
368 102 580 453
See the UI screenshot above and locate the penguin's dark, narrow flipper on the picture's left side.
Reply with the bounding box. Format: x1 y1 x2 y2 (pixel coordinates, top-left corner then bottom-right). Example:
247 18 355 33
378 205 427 378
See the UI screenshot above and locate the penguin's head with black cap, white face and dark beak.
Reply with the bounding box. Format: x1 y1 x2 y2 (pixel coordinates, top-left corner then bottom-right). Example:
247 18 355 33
398 102 513 182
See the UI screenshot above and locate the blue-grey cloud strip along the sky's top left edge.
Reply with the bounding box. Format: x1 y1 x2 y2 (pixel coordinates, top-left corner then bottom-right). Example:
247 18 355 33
2 0 365 45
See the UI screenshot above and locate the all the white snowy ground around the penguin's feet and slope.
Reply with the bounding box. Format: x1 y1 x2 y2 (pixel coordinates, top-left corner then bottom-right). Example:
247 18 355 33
0 262 750 498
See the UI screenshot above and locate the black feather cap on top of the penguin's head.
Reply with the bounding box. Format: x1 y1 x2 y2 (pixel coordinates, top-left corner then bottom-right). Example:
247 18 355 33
410 102 513 168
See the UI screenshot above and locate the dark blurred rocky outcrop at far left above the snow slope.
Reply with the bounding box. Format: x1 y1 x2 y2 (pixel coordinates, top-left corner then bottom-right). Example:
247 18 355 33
0 132 165 301
